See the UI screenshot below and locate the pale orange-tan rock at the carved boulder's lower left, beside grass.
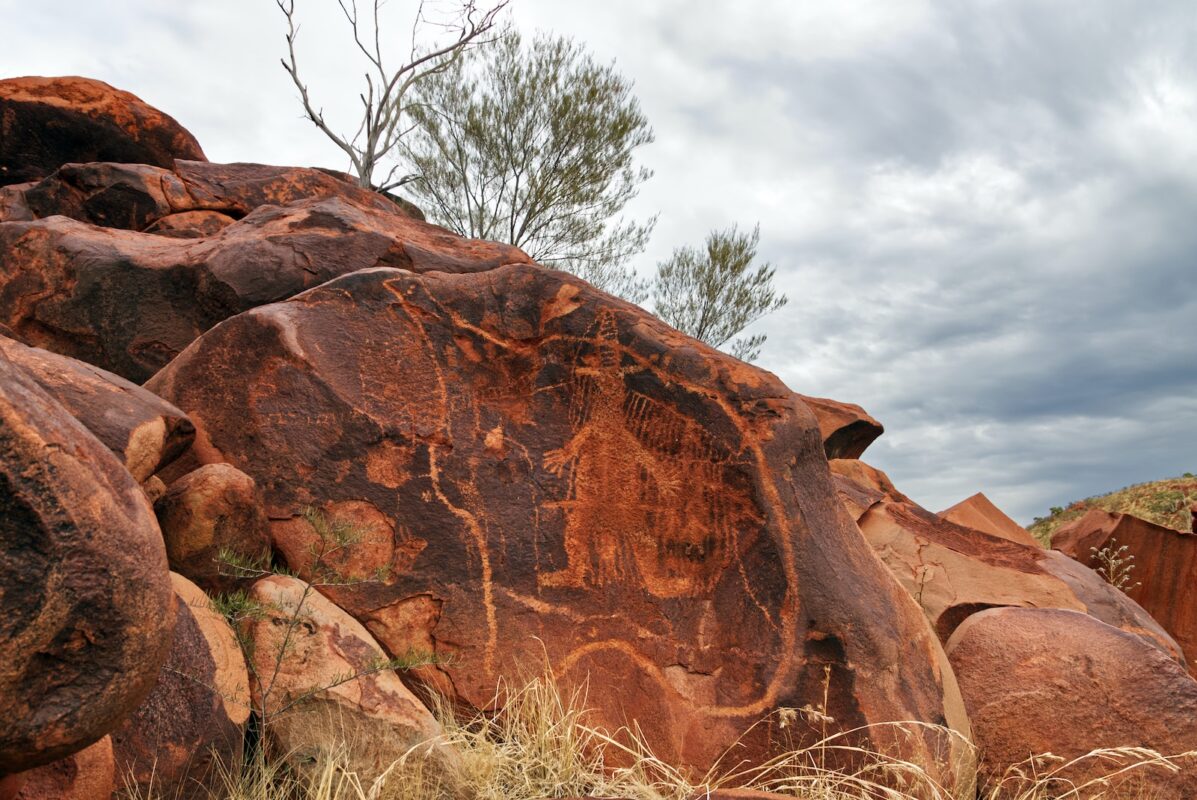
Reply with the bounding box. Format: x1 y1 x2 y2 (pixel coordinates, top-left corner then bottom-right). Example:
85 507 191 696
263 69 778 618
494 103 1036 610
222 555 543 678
245 575 455 782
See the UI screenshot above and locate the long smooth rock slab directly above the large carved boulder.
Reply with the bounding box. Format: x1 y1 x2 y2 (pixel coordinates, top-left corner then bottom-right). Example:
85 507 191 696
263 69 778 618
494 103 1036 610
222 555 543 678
0 198 528 381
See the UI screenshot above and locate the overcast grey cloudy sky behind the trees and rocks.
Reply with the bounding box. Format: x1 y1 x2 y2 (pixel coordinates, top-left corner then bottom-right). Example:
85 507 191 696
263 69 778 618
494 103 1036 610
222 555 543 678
0 0 1197 522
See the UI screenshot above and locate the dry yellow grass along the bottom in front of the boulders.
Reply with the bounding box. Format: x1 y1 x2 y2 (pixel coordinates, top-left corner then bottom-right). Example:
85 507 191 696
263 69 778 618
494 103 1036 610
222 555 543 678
154 679 1197 800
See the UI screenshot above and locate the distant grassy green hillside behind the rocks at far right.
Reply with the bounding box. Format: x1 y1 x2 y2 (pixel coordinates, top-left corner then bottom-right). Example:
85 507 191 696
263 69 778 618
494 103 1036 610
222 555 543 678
1027 472 1197 546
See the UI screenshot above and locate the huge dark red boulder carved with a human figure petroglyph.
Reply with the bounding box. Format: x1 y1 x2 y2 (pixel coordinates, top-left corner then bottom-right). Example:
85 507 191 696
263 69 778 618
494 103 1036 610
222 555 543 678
147 265 967 766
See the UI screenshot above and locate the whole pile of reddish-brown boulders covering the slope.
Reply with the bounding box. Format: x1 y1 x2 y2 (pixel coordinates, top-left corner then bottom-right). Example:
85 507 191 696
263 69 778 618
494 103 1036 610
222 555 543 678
0 78 1197 800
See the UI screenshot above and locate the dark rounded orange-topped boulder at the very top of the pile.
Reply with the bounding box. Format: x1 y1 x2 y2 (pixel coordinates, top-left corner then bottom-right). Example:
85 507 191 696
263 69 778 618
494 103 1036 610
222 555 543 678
0 77 203 186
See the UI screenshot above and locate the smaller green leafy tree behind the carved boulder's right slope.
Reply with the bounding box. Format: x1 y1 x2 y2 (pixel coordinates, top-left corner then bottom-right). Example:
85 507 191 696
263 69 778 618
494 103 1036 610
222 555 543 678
652 225 789 362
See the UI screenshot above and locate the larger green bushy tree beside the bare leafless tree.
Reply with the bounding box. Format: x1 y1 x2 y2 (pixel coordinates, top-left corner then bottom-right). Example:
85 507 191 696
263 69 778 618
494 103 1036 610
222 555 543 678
401 30 656 302
